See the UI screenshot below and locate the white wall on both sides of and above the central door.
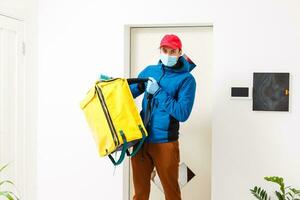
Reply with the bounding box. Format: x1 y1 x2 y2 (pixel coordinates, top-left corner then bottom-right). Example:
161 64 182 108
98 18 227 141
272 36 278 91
38 0 300 200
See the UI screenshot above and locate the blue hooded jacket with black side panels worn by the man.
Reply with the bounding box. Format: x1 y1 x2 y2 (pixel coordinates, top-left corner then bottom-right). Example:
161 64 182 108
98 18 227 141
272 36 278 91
130 56 196 143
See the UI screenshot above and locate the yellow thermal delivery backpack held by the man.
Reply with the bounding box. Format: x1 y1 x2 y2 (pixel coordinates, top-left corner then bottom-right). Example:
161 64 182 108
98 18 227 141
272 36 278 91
80 78 148 165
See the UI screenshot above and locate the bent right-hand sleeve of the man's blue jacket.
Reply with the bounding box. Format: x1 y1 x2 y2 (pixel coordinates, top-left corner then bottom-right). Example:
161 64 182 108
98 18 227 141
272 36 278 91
154 76 196 122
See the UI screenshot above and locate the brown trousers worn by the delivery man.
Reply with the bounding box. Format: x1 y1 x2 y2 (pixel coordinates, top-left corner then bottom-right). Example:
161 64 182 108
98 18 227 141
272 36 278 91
131 141 181 200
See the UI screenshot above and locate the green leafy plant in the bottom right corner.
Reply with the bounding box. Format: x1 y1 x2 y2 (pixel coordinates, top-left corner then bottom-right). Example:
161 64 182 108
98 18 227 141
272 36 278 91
250 176 300 200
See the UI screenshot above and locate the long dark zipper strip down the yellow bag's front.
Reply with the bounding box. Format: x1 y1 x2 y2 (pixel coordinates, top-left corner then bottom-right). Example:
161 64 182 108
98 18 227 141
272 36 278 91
96 86 120 146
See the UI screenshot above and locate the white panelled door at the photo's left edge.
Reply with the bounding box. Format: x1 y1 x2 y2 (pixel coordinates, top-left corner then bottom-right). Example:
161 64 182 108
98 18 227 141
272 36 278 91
0 15 26 199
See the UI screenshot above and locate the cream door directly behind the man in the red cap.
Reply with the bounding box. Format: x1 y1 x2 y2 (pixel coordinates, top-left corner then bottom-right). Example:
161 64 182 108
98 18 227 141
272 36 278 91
129 26 213 200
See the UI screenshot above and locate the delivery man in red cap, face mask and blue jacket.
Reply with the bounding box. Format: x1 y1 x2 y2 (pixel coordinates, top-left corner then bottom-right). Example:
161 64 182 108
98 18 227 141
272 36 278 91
130 34 196 200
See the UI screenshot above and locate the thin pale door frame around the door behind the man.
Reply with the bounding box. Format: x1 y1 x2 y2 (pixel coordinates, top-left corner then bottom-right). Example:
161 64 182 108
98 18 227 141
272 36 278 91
123 22 214 200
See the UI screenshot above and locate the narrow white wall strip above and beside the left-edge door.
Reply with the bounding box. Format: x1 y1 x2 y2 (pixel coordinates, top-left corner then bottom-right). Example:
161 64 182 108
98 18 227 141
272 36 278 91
0 0 38 200
